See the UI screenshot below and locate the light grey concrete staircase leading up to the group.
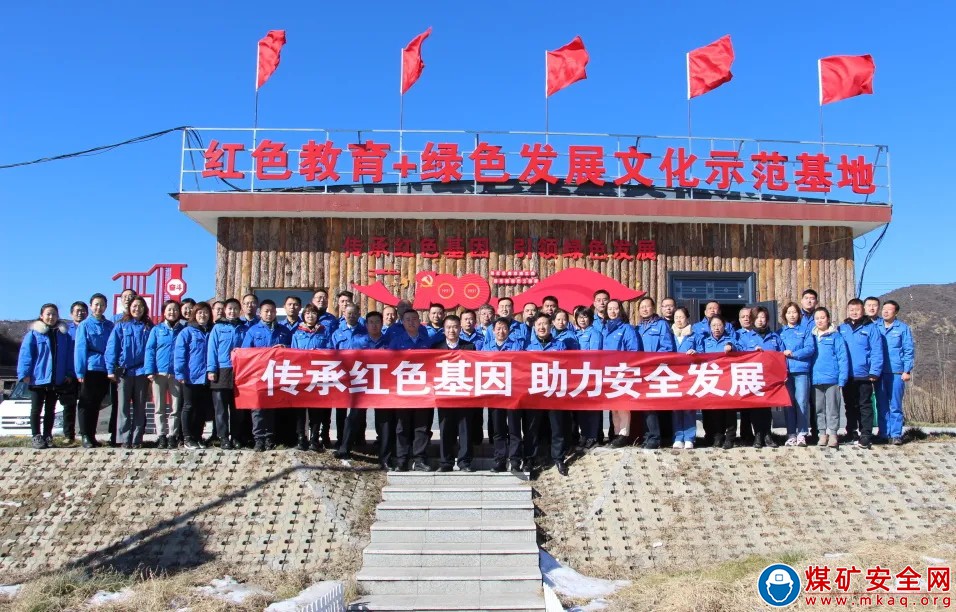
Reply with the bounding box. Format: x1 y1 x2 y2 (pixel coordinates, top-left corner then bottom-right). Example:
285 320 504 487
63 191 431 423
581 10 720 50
349 472 545 612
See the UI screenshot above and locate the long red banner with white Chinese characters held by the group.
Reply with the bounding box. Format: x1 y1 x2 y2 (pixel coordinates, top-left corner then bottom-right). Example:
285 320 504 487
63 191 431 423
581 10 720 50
233 348 790 410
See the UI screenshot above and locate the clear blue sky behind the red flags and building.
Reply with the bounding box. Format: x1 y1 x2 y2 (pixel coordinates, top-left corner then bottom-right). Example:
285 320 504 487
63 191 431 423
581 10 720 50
0 0 956 318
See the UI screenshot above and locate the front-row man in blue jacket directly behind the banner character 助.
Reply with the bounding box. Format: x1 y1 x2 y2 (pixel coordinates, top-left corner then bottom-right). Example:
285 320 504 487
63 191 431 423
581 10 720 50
524 313 568 476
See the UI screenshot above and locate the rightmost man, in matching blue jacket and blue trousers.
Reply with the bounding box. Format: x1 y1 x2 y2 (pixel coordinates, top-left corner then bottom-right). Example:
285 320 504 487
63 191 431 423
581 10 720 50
876 300 916 445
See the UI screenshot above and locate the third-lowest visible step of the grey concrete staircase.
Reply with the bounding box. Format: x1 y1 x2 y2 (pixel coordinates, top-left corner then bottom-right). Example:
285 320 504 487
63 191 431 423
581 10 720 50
363 542 538 567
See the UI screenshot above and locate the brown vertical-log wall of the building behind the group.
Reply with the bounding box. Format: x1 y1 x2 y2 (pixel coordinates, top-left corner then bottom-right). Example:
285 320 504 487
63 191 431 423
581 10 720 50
216 218 855 317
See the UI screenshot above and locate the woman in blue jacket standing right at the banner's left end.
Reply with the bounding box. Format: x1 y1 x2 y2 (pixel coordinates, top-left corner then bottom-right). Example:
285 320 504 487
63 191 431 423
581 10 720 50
206 298 246 450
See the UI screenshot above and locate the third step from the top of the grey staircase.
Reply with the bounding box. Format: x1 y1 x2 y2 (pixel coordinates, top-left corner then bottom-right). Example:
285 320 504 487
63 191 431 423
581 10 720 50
375 499 534 521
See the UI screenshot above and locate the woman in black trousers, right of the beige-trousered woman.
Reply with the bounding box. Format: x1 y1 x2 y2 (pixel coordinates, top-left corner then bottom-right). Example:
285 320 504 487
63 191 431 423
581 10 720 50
173 302 212 450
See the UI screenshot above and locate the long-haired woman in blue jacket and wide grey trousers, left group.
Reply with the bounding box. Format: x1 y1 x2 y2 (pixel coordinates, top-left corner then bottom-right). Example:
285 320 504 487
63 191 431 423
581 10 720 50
106 296 153 449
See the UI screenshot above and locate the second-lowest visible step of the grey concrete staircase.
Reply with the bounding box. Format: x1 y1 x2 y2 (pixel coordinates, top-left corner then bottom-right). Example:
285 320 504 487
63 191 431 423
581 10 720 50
355 567 541 595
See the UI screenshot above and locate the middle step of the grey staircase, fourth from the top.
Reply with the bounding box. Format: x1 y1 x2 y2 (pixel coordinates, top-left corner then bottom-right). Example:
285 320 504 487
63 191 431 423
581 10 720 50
372 517 538 544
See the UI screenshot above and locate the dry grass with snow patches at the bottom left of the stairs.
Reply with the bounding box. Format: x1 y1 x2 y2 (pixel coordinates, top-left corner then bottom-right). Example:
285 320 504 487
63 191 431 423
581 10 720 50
0 563 326 612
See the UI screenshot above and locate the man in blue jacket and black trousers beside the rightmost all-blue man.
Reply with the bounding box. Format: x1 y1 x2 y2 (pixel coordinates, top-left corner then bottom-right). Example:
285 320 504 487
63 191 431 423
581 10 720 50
840 298 883 449
